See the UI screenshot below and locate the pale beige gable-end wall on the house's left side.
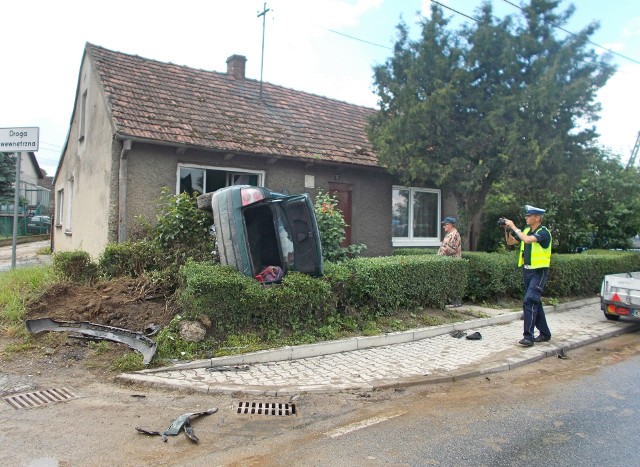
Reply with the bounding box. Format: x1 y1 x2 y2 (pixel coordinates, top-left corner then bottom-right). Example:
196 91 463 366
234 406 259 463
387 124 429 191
51 57 112 258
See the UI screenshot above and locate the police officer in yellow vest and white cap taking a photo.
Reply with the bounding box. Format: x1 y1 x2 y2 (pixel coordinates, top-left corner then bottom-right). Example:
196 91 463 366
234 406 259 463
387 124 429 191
504 205 551 347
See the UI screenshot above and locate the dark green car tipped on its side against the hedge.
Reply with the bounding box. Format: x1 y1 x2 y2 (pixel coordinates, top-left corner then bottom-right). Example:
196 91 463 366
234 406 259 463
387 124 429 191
198 185 324 282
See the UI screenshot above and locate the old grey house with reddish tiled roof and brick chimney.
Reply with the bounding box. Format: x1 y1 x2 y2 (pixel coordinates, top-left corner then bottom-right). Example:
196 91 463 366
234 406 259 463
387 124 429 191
54 43 456 257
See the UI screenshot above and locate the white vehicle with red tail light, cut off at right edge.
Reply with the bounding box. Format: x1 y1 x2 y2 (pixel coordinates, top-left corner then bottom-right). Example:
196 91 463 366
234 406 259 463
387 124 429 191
600 272 640 321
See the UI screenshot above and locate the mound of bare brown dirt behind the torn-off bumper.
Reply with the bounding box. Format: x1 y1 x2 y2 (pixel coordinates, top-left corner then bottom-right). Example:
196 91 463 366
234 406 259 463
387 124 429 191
27 279 175 332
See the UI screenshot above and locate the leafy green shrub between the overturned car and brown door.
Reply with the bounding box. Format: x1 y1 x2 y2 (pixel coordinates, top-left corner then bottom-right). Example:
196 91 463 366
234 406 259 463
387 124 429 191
314 192 367 261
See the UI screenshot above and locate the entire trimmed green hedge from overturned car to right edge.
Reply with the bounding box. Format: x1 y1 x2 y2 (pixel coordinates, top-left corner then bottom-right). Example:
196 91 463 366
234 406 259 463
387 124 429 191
170 252 640 338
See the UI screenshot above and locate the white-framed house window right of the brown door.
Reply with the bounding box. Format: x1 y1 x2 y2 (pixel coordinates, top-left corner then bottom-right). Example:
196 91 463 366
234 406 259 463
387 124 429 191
391 186 440 246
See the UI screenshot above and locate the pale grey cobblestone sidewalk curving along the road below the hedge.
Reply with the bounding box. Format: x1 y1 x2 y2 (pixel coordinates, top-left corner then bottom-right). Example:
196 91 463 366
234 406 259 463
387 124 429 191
120 300 640 395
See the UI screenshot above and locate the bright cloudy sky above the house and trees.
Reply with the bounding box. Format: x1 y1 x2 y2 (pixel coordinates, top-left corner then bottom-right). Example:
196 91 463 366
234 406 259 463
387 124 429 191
0 0 640 175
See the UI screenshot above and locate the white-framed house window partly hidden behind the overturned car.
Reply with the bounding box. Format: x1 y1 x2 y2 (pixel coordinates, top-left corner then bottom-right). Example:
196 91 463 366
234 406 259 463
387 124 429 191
177 164 264 194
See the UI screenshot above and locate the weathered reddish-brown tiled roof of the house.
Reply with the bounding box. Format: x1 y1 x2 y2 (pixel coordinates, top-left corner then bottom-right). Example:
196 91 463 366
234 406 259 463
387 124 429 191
87 44 377 166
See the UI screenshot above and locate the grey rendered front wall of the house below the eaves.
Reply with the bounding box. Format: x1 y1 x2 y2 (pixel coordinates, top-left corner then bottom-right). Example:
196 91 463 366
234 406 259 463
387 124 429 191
126 142 455 256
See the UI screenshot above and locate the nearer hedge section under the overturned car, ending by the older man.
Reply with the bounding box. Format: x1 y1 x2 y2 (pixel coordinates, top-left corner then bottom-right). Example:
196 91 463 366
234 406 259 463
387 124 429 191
178 256 467 336
